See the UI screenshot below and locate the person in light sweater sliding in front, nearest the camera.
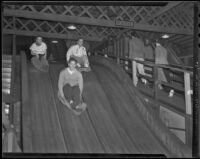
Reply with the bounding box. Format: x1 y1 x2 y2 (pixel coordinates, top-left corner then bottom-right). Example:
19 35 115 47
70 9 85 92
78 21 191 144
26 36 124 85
58 58 87 115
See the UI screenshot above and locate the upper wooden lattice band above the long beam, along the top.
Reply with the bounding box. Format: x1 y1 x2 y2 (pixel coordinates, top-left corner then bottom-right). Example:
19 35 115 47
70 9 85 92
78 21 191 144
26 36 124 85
5 5 162 23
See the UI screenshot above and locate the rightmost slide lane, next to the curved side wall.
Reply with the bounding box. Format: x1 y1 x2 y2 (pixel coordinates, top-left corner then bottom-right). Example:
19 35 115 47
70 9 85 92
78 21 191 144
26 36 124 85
93 66 169 156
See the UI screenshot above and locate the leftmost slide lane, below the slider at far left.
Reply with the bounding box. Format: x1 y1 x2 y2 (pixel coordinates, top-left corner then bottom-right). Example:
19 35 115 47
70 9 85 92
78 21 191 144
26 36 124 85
27 64 68 153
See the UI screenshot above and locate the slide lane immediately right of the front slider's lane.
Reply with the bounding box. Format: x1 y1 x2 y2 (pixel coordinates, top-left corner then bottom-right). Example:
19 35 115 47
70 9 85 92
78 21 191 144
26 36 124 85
82 70 139 153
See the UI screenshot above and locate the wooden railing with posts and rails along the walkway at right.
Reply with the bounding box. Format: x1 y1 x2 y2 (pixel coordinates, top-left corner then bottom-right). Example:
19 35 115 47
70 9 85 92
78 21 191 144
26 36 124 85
95 53 193 146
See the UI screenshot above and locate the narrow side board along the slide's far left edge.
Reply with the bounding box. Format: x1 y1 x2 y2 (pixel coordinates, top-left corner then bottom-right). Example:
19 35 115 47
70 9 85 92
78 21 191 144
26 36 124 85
20 51 32 152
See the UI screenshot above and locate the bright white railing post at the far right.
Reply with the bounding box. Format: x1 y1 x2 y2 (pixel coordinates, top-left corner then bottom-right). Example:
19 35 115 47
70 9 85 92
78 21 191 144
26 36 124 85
184 72 192 115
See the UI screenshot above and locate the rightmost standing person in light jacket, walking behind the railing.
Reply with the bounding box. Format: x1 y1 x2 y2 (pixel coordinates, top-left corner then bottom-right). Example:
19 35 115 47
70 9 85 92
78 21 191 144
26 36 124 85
155 42 174 97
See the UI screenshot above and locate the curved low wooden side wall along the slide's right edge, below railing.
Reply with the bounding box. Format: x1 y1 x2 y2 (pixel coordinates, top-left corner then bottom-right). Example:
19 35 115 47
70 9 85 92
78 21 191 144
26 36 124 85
90 56 192 158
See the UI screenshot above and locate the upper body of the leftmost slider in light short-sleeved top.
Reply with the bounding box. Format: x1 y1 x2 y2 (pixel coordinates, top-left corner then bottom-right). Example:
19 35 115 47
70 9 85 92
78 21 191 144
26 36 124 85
30 37 47 60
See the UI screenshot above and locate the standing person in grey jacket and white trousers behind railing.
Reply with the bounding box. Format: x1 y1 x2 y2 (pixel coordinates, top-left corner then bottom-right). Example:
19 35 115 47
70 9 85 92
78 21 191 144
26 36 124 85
129 32 147 86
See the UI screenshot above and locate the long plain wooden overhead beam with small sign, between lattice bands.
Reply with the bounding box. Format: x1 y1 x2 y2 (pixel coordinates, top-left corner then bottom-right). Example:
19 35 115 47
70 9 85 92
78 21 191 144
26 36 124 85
3 9 193 35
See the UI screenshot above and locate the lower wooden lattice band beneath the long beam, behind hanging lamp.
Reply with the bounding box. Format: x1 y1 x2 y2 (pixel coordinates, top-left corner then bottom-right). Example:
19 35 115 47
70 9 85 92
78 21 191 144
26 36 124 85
3 16 121 39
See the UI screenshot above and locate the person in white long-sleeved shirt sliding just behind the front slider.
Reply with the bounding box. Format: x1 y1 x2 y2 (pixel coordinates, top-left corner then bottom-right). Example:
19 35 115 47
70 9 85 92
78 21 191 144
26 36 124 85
66 39 89 67
